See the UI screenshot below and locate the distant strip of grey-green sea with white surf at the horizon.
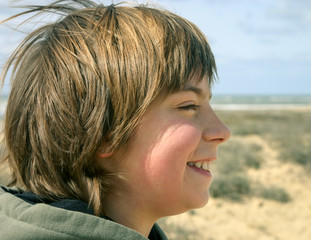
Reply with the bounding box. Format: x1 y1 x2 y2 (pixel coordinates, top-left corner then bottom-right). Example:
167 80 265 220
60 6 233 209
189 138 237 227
0 95 311 118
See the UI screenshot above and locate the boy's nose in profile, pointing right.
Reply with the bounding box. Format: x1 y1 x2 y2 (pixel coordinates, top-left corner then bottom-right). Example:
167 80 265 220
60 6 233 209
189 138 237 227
203 108 231 144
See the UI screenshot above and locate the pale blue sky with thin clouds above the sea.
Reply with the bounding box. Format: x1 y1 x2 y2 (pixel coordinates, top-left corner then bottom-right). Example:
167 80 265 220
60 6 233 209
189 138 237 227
0 0 311 95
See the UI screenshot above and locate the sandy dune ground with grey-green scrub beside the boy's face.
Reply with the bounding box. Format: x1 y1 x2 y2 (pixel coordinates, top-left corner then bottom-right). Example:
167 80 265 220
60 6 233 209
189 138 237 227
160 110 311 240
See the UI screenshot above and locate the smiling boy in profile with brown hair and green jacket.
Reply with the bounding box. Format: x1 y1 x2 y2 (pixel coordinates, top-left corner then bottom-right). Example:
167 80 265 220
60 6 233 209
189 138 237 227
0 0 230 239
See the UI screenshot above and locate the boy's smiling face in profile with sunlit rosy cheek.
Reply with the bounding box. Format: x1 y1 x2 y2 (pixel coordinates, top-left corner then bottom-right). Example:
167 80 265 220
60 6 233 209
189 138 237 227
111 77 230 217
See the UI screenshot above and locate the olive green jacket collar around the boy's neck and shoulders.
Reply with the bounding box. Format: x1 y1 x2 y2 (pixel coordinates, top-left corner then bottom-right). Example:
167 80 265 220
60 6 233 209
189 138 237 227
0 187 167 240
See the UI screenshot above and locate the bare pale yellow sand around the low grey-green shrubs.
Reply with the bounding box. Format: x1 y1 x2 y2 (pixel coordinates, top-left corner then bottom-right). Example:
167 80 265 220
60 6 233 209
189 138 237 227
161 136 311 240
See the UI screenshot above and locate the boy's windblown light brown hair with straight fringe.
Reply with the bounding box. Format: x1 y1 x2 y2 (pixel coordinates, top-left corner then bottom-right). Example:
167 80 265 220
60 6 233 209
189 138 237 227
1 0 216 214
